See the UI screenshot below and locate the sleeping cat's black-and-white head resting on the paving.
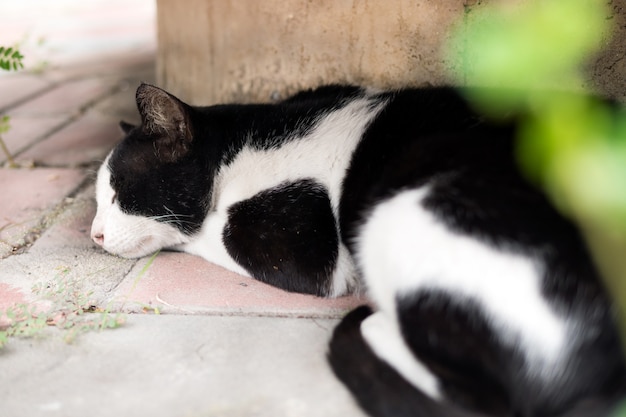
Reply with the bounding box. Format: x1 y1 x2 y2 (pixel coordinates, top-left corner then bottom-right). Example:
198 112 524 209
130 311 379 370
91 84 211 257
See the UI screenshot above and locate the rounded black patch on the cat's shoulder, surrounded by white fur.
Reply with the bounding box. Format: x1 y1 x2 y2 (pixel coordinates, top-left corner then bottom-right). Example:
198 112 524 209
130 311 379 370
223 179 339 295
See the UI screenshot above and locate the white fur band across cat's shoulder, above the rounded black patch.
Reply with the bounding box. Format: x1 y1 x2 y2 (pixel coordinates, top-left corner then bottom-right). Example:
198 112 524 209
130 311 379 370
214 98 384 215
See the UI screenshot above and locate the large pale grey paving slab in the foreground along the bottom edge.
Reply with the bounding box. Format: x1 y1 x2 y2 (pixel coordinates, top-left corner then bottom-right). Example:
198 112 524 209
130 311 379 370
0 315 363 417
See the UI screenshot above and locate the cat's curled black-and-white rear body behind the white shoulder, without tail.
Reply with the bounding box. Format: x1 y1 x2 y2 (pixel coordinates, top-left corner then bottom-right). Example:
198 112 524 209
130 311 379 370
332 88 624 415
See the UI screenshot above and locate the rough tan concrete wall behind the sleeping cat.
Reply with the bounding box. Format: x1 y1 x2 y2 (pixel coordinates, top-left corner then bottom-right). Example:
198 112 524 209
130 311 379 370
157 0 626 104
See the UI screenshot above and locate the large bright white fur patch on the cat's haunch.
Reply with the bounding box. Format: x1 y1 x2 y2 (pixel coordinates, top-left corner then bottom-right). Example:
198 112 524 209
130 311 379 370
358 188 568 375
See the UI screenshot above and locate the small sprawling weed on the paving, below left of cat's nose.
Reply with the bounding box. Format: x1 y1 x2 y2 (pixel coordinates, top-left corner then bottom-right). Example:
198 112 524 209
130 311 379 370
0 267 125 348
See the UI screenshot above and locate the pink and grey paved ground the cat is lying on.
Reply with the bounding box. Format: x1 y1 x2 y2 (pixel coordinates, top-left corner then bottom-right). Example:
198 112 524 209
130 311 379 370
0 0 363 417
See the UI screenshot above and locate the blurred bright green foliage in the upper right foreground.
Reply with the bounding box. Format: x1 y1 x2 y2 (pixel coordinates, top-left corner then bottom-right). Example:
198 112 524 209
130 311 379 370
450 0 626 232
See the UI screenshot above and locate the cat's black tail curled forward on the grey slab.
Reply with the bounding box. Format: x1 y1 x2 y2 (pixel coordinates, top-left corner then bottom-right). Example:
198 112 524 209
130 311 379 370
328 306 486 417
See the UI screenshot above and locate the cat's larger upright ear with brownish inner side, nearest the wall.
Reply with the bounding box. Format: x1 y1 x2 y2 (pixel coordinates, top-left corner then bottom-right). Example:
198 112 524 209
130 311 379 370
136 84 192 162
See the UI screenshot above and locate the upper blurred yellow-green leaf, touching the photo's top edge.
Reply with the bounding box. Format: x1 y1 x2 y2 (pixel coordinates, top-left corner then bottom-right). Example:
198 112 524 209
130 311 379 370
448 0 608 110
